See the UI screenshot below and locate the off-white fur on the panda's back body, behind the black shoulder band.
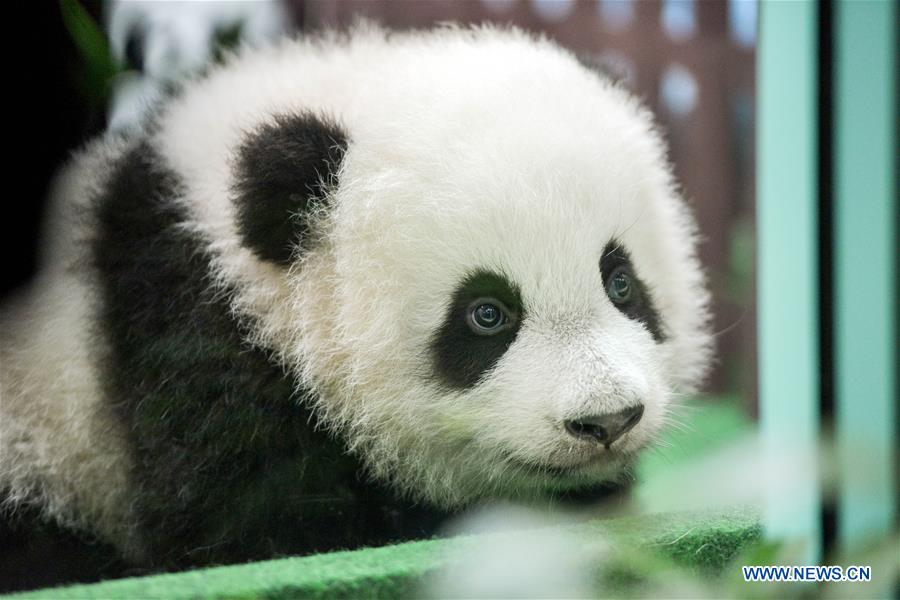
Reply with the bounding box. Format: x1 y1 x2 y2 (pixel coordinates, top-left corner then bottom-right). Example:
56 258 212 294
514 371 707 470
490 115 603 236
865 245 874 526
0 140 139 557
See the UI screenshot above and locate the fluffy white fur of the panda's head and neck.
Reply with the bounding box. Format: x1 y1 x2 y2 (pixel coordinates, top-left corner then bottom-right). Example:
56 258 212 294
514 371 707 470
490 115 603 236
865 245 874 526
0 27 710 548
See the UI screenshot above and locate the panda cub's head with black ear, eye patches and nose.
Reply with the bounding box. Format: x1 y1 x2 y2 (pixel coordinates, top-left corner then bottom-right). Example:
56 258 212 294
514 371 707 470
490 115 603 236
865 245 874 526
175 30 710 507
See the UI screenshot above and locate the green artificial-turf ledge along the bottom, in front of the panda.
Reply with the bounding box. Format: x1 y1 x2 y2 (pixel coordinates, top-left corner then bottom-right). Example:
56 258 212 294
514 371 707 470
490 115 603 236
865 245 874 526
6 510 760 600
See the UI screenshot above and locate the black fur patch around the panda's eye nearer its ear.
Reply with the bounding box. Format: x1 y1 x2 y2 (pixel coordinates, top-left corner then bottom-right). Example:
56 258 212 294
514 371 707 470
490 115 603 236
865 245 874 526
431 271 525 389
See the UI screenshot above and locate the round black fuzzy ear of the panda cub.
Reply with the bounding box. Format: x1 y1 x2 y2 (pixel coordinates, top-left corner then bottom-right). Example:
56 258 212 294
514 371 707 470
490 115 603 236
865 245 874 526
233 112 347 265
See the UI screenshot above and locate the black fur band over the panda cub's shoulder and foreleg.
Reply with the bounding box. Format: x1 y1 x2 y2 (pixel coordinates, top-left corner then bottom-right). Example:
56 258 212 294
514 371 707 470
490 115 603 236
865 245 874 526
86 139 442 569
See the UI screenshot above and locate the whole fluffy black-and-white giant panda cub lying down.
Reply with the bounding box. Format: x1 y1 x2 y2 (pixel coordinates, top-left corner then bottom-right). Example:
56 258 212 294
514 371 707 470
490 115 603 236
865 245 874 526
0 27 710 577
